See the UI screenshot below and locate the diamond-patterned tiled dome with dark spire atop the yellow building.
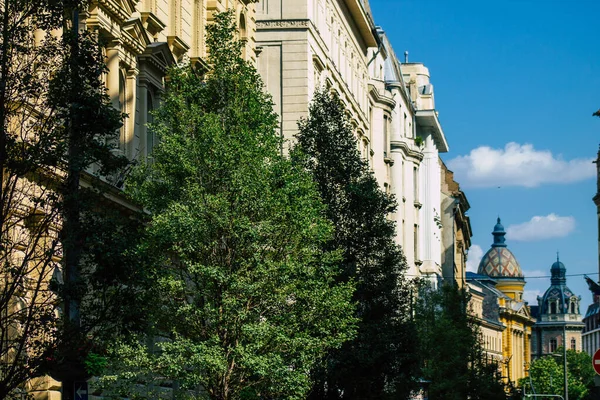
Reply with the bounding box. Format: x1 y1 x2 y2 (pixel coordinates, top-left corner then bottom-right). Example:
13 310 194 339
477 218 523 280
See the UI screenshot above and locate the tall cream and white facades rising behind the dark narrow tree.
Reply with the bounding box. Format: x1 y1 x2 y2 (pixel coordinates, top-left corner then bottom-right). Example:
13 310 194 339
256 0 448 286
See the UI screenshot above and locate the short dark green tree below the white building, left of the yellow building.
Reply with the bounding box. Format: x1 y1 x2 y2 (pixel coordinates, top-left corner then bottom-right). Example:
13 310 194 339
415 284 506 400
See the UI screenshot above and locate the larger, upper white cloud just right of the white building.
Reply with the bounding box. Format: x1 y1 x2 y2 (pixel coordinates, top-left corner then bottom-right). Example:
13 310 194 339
447 142 596 187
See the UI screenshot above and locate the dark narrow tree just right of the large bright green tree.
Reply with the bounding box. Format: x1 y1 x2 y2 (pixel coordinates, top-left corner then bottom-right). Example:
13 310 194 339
292 90 418 399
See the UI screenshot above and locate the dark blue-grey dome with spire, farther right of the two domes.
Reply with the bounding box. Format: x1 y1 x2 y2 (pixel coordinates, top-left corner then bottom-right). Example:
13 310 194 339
538 257 579 315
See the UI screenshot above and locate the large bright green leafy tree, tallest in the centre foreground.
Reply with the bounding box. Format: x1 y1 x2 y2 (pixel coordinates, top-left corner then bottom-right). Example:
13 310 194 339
105 12 354 400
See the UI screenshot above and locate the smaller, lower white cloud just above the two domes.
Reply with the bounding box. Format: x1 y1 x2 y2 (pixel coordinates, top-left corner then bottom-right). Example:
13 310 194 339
506 213 575 242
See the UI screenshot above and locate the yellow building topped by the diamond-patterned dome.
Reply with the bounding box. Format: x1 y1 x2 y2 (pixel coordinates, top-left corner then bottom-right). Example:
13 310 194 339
477 218 535 384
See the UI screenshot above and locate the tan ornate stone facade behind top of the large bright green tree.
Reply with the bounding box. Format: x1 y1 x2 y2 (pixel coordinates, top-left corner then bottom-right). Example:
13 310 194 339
28 0 256 399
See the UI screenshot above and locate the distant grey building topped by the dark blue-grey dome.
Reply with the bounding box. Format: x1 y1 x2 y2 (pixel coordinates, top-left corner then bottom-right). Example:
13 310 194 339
531 257 584 358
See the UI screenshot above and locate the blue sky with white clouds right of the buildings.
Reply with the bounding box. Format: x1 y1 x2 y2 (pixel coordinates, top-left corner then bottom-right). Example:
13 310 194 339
370 0 600 306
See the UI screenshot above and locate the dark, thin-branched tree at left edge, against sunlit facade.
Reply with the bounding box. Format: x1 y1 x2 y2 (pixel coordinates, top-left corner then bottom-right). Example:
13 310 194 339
0 0 149 398
